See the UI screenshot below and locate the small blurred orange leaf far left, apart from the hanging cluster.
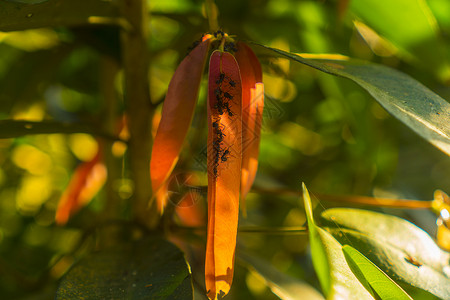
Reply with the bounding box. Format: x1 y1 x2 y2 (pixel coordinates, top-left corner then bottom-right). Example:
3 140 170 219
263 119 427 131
55 149 107 225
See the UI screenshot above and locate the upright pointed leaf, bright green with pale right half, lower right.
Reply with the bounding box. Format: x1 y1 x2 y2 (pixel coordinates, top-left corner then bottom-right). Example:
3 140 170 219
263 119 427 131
303 184 374 299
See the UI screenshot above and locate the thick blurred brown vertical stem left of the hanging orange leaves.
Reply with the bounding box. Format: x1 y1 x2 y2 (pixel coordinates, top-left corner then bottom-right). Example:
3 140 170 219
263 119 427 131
121 0 157 227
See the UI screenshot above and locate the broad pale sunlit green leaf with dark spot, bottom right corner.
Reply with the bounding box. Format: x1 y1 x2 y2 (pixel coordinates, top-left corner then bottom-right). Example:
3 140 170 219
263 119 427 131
322 208 450 299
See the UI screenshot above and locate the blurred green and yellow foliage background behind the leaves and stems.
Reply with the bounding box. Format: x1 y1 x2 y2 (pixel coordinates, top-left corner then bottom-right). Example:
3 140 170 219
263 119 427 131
0 0 450 299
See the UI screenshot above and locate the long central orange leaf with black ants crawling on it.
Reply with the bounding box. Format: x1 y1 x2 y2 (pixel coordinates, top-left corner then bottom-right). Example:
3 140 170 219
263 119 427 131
205 51 242 299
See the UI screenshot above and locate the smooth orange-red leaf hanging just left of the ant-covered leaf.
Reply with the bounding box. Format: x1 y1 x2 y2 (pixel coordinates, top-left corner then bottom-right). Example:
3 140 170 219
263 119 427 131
150 40 209 213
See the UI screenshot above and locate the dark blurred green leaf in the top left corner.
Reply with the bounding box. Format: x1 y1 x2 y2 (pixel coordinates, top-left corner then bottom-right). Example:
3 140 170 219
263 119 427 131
0 0 120 31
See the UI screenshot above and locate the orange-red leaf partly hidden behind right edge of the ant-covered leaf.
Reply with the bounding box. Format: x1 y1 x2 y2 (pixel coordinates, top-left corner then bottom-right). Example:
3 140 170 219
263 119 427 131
236 42 264 216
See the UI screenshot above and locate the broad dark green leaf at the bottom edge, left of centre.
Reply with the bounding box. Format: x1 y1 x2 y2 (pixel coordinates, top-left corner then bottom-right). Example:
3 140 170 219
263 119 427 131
56 238 193 300
